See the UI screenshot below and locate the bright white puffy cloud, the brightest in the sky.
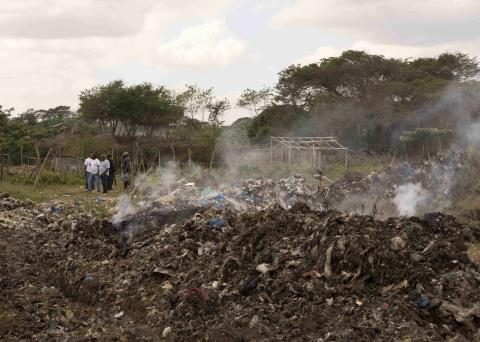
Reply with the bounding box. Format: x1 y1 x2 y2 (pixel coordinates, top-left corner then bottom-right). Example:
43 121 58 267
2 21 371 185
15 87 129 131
158 20 246 69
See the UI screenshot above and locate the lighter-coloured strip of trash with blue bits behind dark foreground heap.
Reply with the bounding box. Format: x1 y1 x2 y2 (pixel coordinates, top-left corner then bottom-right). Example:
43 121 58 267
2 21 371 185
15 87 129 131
113 173 324 234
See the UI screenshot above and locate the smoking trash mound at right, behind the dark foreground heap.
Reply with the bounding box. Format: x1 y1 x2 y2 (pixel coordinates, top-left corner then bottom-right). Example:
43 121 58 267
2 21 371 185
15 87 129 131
327 152 465 219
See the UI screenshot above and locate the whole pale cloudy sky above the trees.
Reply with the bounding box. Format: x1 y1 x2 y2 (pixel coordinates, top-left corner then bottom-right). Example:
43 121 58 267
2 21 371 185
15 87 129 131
0 0 480 122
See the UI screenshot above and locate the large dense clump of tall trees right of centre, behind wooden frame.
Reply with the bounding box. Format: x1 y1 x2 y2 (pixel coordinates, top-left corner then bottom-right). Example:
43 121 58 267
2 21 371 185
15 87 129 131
234 50 480 153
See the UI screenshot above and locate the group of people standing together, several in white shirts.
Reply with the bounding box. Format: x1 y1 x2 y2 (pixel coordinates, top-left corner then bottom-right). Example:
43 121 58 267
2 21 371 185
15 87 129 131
85 152 130 194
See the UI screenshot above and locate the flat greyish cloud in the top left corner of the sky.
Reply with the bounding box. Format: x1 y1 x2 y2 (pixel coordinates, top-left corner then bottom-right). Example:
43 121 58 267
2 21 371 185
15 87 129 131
0 0 154 39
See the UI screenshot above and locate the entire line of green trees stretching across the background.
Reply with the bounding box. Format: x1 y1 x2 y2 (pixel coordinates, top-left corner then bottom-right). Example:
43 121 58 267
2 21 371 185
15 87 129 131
0 50 480 162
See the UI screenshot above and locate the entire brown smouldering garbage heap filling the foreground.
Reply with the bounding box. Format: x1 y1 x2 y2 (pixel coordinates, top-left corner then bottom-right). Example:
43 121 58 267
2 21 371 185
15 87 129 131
0 158 480 341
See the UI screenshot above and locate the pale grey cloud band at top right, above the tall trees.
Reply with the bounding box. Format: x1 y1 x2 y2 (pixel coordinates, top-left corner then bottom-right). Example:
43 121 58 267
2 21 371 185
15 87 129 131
272 0 480 45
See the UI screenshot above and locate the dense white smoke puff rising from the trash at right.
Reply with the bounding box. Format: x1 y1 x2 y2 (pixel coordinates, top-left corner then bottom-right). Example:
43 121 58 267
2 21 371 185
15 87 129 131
393 183 428 216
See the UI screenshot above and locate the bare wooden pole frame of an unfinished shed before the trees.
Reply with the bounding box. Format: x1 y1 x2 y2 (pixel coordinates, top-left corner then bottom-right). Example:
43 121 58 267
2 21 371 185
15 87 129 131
270 136 348 167
